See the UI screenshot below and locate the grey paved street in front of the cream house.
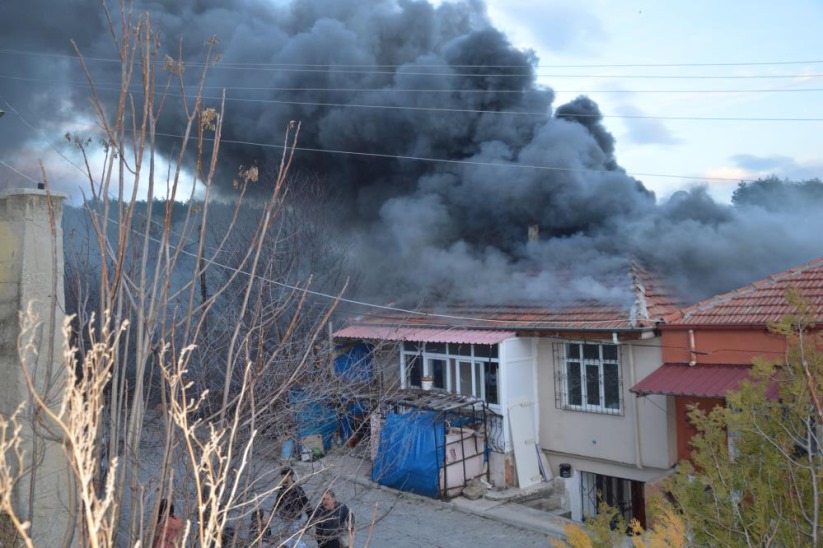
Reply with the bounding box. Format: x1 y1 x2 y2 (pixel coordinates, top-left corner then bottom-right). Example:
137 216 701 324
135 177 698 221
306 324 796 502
142 414 562 548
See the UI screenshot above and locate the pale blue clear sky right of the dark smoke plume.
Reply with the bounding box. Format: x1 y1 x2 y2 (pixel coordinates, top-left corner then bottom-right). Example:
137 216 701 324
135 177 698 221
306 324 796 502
487 0 823 201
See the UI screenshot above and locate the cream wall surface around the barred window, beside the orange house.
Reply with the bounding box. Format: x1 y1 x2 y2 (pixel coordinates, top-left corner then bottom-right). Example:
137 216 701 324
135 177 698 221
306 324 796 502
537 338 676 481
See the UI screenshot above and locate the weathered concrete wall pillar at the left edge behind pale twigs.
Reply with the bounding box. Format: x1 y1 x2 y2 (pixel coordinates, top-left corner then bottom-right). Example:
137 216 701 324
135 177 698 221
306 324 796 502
0 190 74 546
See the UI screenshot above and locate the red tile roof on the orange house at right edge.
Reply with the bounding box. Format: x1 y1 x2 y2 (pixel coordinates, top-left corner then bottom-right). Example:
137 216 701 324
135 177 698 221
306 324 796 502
669 257 823 325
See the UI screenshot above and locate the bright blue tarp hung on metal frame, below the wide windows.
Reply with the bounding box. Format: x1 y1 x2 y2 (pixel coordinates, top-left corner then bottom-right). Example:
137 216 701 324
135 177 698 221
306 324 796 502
372 411 445 497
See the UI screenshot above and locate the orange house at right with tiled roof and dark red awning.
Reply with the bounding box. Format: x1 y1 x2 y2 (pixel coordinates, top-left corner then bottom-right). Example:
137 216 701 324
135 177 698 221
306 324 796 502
631 258 823 460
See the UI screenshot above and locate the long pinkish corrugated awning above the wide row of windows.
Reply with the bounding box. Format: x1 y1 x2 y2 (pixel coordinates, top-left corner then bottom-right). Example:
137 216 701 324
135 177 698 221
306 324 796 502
334 325 515 344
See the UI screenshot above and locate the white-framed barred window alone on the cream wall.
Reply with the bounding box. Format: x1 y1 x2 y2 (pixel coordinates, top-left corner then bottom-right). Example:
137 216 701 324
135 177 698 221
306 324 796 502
555 342 623 415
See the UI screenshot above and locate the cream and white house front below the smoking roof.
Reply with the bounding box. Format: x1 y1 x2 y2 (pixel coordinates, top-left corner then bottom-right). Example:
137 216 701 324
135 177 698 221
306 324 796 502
335 266 677 521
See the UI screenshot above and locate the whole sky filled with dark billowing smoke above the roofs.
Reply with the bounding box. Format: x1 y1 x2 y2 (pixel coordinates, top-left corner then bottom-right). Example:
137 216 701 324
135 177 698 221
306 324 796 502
0 0 823 302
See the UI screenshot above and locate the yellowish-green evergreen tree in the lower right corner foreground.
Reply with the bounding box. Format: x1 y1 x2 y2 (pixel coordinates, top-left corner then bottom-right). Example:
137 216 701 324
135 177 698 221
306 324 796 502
668 291 823 546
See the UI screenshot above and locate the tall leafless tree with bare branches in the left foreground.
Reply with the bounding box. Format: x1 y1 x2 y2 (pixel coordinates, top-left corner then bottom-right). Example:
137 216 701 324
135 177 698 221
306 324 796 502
0 1 354 546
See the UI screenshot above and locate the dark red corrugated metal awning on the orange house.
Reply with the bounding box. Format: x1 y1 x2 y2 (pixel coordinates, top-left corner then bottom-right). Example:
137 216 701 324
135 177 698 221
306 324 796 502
631 363 752 398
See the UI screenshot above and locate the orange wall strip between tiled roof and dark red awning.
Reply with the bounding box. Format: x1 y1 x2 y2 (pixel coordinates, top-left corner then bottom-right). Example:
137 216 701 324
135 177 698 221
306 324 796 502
661 327 786 364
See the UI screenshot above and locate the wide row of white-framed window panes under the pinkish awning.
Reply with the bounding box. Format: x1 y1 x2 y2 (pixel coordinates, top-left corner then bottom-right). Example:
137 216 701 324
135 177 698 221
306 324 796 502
402 342 499 404
